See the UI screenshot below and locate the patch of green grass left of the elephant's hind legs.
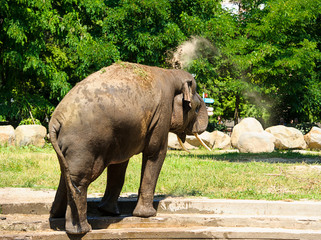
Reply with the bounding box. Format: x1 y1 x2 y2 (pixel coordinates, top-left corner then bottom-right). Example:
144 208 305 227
0 145 60 189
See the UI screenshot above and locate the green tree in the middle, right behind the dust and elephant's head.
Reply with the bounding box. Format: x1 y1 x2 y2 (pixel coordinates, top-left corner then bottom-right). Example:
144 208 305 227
170 1 258 123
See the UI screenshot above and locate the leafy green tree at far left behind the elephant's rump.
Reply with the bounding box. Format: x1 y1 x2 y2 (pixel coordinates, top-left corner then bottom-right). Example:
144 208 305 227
0 0 119 122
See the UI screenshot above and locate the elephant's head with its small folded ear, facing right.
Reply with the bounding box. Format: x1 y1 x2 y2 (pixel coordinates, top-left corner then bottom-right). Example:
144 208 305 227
170 74 208 150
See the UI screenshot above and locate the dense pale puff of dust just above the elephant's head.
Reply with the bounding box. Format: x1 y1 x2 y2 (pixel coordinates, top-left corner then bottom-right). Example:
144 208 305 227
168 36 219 69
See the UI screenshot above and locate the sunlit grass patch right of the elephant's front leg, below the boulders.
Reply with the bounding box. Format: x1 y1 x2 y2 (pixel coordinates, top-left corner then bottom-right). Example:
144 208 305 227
158 151 321 200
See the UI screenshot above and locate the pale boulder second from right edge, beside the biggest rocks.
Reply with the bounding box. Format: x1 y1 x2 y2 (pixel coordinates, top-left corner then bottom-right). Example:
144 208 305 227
265 125 307 149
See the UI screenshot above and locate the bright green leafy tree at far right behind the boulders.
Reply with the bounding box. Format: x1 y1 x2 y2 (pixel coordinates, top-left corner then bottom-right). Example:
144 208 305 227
240 0 321 123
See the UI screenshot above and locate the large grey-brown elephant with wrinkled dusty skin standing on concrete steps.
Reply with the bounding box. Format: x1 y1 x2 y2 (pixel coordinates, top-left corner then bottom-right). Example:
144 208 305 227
49 63 208 234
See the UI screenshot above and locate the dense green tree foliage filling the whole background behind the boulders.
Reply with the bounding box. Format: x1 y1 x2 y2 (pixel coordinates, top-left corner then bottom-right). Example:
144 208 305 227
0 0 321 125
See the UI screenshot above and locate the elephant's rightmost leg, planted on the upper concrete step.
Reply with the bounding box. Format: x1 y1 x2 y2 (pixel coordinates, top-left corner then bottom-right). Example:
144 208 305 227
133 140 167 217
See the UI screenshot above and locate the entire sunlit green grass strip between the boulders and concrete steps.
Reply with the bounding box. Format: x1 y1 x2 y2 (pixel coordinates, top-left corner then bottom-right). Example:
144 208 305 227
0 146 321 200
